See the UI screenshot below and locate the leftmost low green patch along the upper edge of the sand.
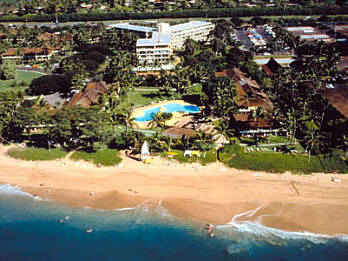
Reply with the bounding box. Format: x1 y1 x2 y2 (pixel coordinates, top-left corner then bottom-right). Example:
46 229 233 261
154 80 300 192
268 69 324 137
8 148 67 161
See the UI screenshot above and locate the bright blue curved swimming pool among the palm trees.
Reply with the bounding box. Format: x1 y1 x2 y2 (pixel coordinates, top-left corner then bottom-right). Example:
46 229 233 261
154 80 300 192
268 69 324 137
135 103 199 122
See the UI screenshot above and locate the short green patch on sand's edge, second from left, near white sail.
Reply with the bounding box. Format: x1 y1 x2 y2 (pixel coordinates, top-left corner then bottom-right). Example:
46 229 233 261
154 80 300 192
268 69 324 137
70 149 122 166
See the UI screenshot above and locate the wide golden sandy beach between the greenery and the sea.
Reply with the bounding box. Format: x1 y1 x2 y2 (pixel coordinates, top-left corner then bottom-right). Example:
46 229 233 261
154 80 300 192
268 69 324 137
0 143 348 235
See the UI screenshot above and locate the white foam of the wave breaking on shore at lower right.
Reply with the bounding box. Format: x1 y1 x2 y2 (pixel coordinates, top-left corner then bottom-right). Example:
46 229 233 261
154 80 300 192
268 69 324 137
216 206 348 244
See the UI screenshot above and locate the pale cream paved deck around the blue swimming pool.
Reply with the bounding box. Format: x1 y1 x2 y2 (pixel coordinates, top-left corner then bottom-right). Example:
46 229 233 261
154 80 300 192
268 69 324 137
132 100 198 128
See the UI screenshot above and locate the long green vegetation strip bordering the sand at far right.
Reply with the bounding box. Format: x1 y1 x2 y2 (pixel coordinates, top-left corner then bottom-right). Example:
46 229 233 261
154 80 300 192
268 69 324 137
221 145 348 174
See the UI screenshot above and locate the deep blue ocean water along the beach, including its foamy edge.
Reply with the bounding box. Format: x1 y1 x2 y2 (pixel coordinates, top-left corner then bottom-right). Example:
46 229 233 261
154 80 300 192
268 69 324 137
0 185 348 261
